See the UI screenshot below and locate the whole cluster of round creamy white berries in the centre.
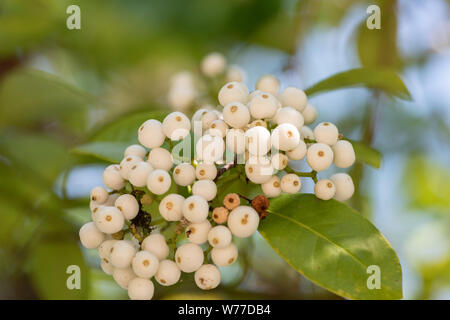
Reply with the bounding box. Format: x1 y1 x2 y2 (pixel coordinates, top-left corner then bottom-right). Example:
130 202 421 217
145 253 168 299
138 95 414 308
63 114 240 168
80 54 355 299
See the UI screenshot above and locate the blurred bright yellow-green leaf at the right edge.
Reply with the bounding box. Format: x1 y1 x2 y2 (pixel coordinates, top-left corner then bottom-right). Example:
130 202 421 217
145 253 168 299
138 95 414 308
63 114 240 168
404 156 450 215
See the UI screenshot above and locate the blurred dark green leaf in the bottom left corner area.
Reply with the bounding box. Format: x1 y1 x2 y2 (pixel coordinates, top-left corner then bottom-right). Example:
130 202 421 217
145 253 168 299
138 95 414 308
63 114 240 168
30 240 89 300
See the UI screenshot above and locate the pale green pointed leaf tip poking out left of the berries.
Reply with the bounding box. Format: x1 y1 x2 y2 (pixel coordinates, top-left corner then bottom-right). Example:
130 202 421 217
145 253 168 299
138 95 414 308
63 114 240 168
72 142 129 163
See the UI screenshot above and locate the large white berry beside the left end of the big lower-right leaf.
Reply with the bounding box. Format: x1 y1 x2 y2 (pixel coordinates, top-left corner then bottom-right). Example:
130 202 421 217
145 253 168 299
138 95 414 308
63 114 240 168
227 206 259 238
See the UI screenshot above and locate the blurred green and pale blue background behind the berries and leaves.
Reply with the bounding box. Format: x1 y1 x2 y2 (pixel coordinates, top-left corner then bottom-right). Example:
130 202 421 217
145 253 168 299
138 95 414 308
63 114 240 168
0 0 450 299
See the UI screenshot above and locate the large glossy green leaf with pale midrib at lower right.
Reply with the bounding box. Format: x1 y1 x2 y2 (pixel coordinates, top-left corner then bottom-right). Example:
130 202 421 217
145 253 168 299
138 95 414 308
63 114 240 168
259 194 402 299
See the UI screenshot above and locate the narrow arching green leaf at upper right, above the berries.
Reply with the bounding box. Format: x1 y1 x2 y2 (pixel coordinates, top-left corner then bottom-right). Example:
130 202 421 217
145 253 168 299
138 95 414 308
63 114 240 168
305 68 411 100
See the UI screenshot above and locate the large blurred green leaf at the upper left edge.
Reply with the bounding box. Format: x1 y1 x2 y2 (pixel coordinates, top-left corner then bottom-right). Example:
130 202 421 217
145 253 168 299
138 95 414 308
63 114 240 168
0 69 93 126
